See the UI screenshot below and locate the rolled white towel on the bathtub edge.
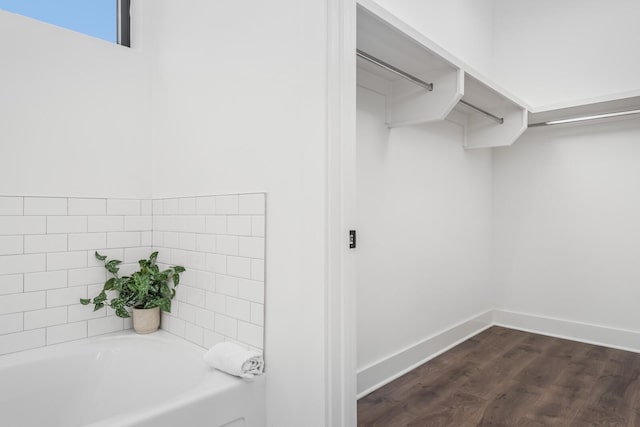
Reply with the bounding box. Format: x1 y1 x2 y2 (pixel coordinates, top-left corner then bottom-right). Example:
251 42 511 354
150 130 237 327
204 342 264 378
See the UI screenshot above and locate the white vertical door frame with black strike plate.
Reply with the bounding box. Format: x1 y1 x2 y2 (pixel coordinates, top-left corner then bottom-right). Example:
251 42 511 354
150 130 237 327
325 0 357 427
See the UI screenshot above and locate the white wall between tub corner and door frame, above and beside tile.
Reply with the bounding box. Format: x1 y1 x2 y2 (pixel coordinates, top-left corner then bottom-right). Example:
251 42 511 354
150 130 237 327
147 0 327 426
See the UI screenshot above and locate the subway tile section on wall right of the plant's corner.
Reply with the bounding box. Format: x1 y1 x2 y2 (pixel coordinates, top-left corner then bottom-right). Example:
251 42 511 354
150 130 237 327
153 193 265 352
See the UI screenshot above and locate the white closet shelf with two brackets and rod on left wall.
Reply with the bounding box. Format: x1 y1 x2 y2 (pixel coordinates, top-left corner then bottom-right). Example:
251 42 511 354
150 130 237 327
357 0 527 148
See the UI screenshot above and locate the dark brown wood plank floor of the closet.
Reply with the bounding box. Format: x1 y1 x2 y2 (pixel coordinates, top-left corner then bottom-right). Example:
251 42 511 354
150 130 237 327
358 326 640 427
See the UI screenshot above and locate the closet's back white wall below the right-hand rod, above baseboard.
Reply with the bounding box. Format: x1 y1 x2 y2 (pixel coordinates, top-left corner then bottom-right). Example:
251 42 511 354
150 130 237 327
493 120 640 332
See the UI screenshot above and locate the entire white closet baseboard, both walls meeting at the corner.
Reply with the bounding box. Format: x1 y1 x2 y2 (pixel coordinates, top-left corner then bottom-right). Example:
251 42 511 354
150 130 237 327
357 310 640 399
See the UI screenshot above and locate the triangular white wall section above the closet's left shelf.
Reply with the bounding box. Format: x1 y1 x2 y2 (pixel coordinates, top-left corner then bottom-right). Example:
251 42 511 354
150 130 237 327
376 0 494 75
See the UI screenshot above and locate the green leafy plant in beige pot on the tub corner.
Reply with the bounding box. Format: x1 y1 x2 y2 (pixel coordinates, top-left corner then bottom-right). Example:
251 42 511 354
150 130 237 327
80 252 185 334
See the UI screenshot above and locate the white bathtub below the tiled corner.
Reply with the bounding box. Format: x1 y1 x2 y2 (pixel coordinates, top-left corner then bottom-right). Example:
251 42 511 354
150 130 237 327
0 331 265 427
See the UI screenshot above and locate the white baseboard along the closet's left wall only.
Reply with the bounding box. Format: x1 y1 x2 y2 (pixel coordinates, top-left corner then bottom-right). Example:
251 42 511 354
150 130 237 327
357 311 493 399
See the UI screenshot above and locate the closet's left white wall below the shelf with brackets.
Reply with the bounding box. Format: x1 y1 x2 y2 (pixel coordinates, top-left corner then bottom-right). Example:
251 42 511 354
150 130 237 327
357 88 494 370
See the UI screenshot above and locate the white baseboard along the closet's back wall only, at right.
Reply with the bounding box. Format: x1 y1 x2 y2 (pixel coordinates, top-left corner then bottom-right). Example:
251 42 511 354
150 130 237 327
493 310 640 353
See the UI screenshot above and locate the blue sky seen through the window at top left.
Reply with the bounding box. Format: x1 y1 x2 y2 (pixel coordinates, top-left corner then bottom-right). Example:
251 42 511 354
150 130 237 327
0 0 117 43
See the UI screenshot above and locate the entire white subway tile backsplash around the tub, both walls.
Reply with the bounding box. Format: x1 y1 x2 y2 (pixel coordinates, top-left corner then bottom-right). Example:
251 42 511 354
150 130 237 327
0 194 265 354
